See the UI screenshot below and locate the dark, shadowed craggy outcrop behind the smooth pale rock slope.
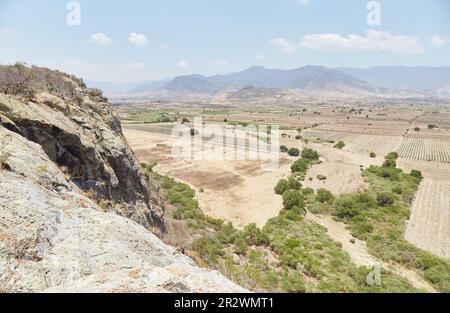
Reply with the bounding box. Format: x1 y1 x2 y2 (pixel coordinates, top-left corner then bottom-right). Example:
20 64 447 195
0 68 165 232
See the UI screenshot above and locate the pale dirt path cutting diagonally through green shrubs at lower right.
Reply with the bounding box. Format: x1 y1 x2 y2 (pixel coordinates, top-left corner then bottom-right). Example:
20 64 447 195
307 213 436 293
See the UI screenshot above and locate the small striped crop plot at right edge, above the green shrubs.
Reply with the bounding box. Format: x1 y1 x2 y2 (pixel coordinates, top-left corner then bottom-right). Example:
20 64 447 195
398 138 450 163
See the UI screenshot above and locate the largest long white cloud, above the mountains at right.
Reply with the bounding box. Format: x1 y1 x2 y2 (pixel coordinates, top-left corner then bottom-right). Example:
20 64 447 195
300 30 424 55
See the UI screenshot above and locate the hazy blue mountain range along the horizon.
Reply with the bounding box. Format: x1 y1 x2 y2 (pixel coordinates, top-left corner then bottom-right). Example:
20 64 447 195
88 66 450 98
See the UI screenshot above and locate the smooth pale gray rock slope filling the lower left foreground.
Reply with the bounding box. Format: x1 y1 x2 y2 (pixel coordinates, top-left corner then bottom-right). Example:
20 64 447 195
0 109 244 292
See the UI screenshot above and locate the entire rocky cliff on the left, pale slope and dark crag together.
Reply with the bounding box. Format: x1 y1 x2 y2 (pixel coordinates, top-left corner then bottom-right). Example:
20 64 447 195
0 65 243 292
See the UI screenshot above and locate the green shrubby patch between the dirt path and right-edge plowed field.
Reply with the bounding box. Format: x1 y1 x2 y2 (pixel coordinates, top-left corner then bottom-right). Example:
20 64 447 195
333 152 450 292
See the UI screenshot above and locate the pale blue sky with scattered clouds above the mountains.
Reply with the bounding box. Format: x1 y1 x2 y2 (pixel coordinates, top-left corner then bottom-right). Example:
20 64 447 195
0 0 450 82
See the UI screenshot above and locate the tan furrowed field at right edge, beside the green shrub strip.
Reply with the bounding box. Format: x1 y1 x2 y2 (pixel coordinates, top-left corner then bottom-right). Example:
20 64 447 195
405 179 450 258
